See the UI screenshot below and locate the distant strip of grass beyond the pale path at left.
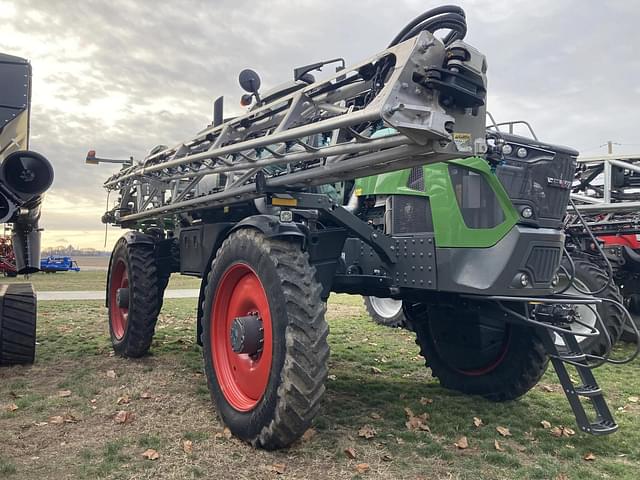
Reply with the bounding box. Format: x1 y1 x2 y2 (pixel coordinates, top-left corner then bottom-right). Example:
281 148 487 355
2 270 200 292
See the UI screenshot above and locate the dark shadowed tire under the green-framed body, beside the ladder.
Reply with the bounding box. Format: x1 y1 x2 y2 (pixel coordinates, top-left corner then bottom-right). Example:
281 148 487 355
413 306 549 402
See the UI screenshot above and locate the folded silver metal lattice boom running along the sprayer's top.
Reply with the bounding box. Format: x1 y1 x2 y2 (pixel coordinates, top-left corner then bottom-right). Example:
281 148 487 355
104 31 486 224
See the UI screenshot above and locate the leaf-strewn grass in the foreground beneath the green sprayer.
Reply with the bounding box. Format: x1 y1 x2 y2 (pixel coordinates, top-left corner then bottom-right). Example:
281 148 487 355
0 296 640 480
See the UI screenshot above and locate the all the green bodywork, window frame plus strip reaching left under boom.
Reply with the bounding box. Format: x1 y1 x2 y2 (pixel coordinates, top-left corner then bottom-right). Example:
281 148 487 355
356 158 519 248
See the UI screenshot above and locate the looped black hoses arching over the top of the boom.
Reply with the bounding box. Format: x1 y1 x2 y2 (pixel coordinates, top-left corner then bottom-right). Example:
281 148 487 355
389 5 467 47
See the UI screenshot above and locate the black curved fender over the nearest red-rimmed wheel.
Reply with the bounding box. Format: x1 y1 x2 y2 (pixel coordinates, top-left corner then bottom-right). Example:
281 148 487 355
196 215 307 346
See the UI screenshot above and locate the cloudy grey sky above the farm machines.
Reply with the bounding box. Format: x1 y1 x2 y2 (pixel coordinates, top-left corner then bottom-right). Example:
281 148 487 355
0 0 640 249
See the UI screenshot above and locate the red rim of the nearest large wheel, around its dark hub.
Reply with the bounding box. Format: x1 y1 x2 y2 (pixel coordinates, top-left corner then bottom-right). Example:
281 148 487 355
209 263 272 412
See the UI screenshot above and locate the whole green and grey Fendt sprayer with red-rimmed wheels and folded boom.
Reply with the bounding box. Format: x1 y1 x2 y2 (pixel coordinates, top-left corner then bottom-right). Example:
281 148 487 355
94 7 632 448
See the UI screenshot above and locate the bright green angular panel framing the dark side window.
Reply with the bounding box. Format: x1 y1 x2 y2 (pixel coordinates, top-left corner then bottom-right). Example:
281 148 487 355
424 158 519 248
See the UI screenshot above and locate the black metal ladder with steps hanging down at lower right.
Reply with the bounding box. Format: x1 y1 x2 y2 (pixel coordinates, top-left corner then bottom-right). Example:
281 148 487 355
541 329 618 435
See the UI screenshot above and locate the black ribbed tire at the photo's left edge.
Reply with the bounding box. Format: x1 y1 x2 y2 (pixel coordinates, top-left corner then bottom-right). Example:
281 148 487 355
0 283 37 365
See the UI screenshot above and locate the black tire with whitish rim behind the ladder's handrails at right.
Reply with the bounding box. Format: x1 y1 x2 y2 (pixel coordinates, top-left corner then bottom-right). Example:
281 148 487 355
556 257 625 356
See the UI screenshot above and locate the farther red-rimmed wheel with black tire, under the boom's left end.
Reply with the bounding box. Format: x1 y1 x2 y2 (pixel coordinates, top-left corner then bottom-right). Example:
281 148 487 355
107 238 162 358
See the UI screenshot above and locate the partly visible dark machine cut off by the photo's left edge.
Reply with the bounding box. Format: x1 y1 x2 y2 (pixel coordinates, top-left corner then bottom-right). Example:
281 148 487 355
0 53 53 366
